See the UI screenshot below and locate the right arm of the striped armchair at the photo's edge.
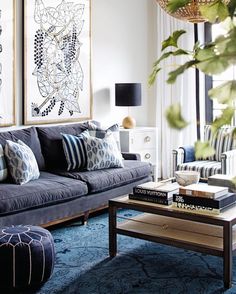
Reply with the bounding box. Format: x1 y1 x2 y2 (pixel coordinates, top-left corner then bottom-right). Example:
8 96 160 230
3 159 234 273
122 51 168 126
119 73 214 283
221 149 236 175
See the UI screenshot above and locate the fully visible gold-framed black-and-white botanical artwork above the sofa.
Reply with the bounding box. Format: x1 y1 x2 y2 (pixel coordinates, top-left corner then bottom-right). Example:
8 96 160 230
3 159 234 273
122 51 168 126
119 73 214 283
24 0 92 124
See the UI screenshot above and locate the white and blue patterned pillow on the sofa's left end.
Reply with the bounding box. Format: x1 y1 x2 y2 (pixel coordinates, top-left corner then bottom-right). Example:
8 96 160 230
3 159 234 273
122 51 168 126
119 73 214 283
5 140 40 185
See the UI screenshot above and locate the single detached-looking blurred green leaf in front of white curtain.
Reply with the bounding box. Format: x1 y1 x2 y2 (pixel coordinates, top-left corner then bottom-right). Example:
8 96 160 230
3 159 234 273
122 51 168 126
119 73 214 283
165 103 189 130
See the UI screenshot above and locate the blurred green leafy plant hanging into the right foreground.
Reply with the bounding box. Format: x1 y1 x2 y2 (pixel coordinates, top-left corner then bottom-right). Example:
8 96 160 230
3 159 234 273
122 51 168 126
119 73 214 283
149 0 236 158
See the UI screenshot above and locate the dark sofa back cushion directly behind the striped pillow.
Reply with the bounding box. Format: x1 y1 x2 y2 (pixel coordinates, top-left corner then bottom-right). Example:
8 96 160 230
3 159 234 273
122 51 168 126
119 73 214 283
37 122 99 170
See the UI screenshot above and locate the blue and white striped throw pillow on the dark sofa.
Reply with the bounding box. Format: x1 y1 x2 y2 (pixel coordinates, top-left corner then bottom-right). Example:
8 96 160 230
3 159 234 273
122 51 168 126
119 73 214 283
62 130 89 171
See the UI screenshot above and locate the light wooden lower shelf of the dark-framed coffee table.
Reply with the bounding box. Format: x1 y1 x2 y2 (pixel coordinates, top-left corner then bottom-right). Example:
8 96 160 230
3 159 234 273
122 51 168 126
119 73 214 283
116 213 236 256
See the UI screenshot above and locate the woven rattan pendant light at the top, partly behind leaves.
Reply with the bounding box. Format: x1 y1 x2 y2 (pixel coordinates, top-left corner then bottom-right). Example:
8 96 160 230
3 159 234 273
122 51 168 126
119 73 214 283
156 0 229 23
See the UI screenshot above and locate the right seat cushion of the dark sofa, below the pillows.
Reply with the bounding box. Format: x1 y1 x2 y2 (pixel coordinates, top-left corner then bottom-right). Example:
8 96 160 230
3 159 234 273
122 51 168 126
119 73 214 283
57 160 151 193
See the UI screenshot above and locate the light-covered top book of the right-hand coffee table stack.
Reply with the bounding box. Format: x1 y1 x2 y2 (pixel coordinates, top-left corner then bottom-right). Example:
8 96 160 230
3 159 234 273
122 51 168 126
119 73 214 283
179 184 229 199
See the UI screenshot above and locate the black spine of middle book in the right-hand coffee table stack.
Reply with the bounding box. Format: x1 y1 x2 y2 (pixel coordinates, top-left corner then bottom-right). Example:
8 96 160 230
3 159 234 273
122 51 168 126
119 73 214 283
173 194 220 209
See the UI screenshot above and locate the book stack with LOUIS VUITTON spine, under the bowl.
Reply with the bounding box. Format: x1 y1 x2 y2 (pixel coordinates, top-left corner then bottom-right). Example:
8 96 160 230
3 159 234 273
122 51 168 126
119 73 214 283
129 181 179 205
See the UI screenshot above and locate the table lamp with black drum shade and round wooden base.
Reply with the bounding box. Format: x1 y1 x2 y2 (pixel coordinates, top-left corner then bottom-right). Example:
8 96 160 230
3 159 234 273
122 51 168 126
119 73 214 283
115 83 142 129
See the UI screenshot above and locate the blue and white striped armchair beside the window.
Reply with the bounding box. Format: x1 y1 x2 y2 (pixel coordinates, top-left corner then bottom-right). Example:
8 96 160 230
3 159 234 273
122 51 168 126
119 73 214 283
172 125 236 179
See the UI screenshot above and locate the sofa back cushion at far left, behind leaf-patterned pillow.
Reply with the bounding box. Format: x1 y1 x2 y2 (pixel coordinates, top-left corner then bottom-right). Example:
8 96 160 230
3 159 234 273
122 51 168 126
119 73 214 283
0 127 45 170
